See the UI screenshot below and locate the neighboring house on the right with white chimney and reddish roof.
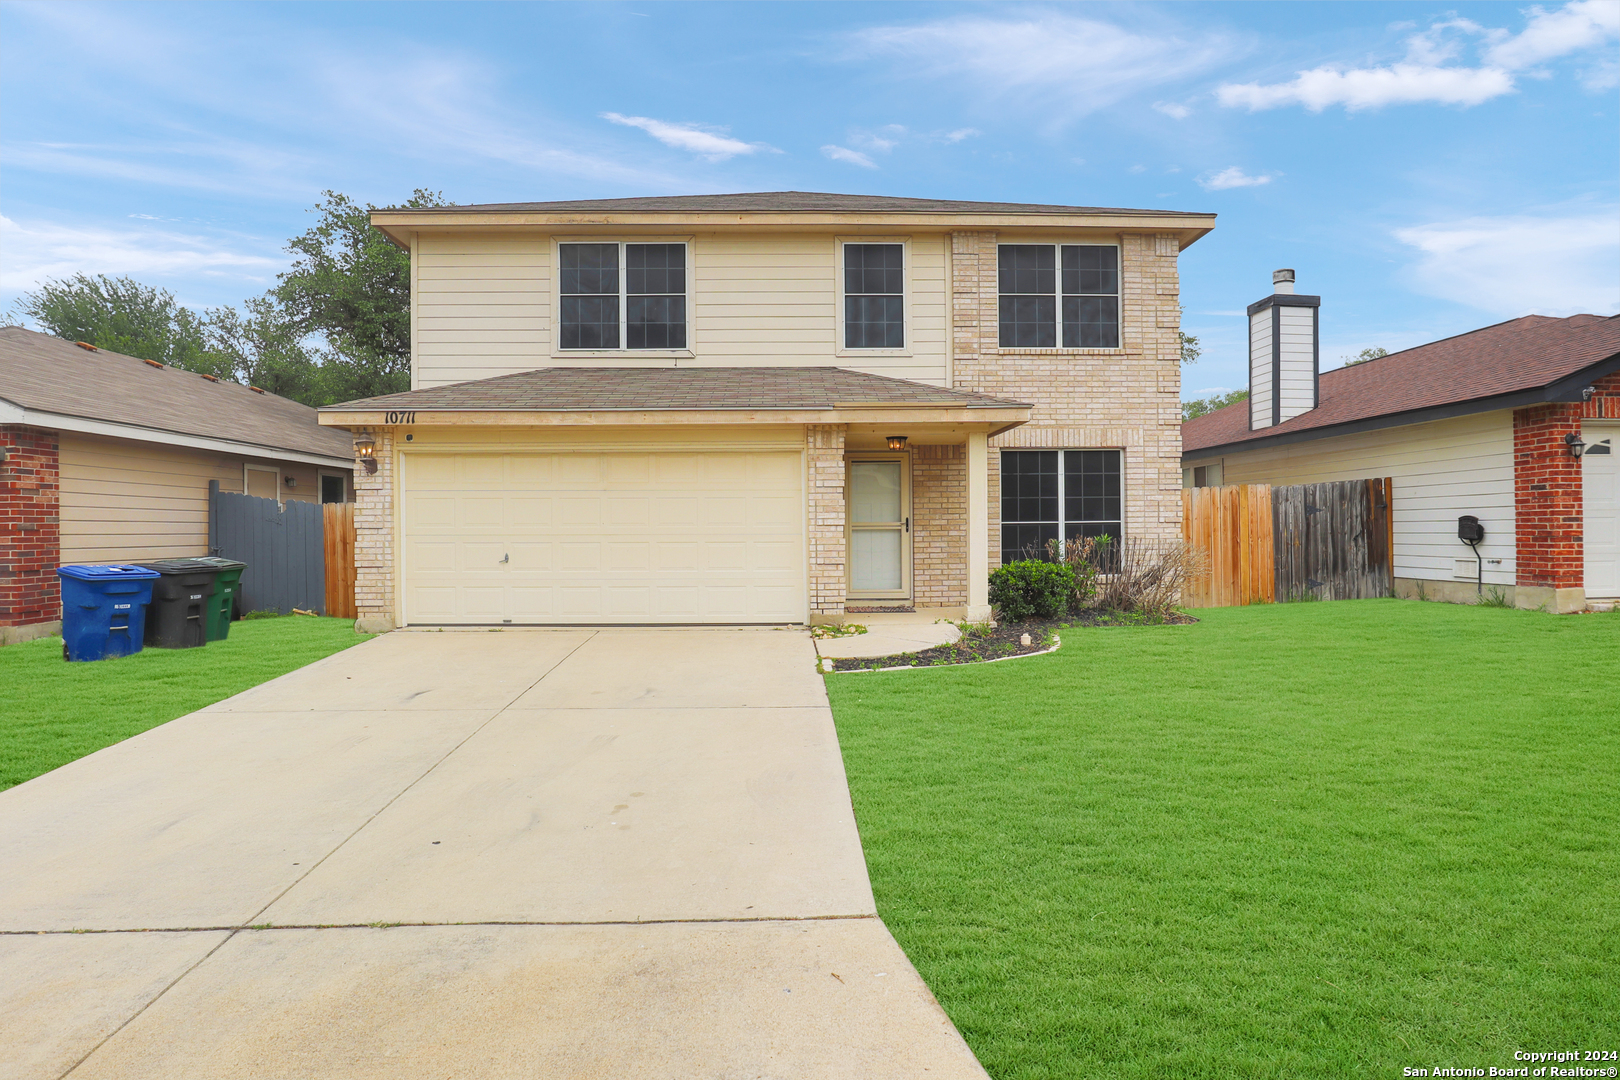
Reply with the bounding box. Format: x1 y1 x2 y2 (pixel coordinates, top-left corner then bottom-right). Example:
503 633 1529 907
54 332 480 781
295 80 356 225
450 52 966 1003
1181 270 1620 612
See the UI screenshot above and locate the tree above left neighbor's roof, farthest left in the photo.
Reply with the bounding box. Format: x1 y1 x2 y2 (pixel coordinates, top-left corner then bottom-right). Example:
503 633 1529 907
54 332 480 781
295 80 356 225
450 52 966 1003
13 274 232 379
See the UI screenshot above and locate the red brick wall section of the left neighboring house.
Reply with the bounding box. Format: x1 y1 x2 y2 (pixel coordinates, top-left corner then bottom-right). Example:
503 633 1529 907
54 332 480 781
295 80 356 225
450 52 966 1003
0 424 62 627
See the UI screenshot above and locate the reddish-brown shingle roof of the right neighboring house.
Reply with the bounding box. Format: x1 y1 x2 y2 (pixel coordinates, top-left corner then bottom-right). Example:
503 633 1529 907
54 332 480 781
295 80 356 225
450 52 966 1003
1181 316 1620 453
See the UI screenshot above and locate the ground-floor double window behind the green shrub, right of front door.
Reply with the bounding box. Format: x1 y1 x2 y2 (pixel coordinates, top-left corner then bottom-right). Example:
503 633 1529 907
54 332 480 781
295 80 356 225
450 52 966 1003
1001 450 1123 562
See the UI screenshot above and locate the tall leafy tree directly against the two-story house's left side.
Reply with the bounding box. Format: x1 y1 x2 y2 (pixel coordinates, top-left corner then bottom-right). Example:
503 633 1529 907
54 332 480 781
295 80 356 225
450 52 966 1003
267 189 450 403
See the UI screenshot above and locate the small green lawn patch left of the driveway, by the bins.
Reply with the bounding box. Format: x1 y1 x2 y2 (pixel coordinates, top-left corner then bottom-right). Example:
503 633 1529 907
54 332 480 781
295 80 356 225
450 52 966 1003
0 615 365 790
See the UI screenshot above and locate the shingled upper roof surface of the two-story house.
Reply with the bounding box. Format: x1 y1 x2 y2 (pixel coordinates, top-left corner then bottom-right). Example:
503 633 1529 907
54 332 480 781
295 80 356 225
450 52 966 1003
379 191 1210 217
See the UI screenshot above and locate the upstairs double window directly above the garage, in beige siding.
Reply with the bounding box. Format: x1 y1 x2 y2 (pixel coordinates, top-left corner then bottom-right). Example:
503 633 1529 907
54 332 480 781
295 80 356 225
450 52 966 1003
557 243 687 350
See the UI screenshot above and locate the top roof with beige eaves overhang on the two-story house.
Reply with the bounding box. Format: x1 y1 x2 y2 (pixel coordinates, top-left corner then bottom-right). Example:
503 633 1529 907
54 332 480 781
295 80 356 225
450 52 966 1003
371 191 1215 249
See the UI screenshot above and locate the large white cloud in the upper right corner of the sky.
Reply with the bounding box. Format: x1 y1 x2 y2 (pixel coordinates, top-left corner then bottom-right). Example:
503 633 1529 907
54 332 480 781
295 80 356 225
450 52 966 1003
1215 0 1620 112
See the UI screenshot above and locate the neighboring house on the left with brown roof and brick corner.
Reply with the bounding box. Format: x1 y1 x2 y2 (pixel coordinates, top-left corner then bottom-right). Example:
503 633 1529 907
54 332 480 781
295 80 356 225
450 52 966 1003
0 327 353 643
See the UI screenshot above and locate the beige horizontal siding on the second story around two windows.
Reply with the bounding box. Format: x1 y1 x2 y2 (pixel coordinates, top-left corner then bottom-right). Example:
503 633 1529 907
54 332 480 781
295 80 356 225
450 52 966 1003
411 233 948 389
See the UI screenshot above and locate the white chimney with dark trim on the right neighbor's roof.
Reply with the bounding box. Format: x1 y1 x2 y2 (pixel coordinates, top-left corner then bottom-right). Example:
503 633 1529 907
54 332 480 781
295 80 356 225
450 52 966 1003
1249 270 1322 431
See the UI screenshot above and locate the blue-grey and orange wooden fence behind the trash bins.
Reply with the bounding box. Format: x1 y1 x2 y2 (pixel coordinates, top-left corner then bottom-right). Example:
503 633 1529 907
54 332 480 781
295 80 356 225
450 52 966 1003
207 481 355 619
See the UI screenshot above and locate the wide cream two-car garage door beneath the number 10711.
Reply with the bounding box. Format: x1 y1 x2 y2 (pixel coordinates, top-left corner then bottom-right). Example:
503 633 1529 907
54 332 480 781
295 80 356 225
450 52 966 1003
400 450 807 625
